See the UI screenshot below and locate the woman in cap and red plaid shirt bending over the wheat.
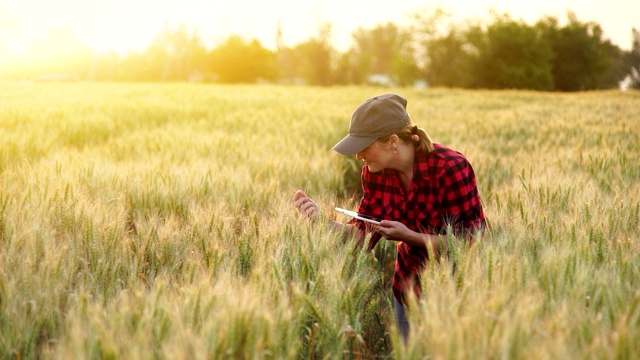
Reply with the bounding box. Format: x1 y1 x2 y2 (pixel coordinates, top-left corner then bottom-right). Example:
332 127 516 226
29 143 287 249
293 94 486 341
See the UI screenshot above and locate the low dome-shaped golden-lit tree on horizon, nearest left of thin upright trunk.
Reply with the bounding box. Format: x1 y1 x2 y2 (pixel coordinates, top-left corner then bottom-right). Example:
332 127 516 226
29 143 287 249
210 35 276 83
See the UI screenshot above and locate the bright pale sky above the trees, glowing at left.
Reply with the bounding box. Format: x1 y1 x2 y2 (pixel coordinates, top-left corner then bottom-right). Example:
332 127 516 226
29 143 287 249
0 0 640 59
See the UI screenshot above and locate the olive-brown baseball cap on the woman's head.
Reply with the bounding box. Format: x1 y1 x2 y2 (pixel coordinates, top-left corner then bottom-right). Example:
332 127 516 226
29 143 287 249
333 93 411 155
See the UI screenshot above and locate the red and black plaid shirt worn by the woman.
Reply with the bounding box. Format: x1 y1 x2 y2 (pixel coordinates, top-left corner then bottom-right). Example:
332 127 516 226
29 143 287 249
350 144 486 302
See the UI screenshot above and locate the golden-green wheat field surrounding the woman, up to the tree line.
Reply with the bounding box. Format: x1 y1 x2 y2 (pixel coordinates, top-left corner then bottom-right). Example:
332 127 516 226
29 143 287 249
0 83 640 359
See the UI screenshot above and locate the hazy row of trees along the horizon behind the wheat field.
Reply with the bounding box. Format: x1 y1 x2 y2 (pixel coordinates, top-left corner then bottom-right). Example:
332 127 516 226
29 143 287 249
0 10 640 91
